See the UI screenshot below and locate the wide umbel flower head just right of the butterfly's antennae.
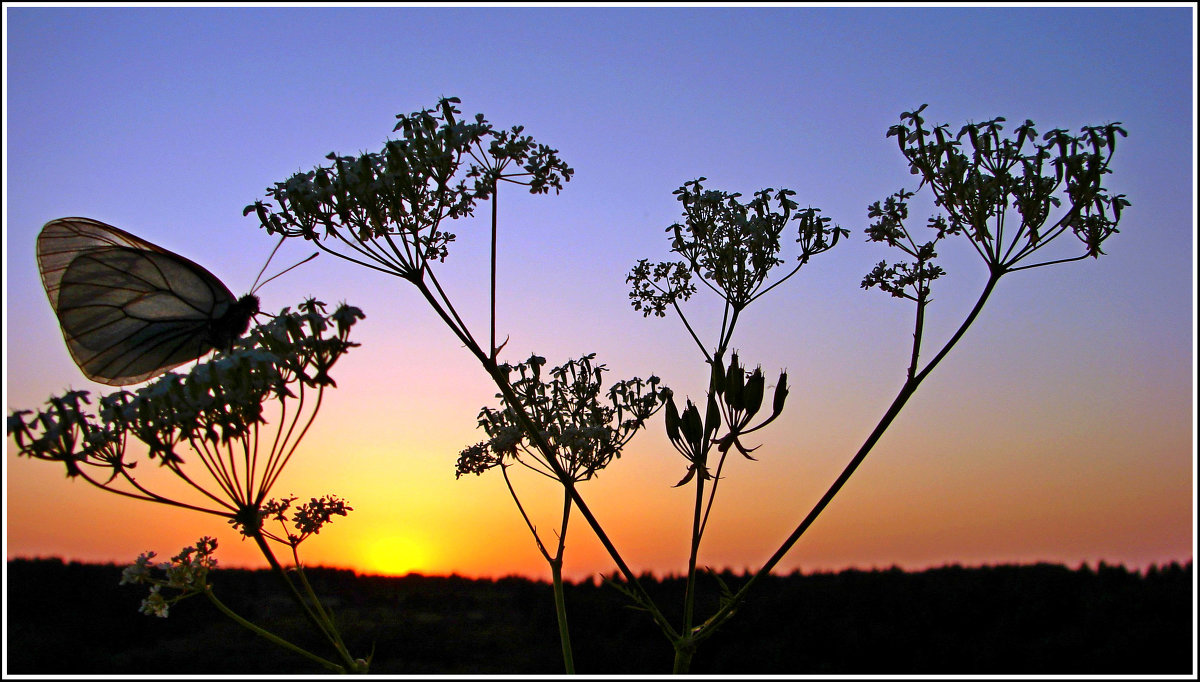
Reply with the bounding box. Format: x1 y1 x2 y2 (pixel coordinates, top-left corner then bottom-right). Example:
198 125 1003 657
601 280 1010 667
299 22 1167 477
242 97 574 281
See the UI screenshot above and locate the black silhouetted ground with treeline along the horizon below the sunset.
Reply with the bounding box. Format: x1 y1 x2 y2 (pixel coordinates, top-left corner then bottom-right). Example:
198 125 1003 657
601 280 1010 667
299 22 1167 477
5 560 1195 675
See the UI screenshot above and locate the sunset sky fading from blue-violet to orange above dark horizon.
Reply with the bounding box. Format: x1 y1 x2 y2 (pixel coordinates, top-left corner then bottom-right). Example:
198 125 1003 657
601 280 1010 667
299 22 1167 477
4 6 1195 578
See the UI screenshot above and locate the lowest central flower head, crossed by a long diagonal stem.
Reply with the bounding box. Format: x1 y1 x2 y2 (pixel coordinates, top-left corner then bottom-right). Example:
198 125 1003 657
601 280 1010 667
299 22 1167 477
456 354 671 480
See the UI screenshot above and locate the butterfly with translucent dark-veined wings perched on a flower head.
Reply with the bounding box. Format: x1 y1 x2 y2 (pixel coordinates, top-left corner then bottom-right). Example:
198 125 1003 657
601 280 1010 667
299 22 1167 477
37 217 258 385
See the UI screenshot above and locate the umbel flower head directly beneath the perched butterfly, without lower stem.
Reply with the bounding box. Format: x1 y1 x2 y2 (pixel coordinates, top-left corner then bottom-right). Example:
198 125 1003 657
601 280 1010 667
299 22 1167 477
7 299 364 534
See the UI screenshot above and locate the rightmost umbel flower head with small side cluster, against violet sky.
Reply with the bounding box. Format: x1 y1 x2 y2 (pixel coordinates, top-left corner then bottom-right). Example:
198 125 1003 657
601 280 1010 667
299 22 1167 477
863 104 1129 295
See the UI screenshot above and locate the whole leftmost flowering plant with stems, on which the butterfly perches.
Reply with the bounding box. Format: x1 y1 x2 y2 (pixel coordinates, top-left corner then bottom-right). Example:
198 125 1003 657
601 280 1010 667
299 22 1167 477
7 299 367 671
